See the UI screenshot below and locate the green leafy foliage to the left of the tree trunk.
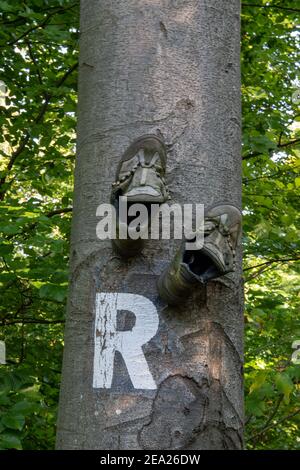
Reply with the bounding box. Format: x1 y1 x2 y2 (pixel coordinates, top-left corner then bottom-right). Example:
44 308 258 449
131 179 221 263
0 0 79 449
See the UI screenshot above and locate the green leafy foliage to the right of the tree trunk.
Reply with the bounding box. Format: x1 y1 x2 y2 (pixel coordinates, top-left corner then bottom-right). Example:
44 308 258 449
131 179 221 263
242 1 300 449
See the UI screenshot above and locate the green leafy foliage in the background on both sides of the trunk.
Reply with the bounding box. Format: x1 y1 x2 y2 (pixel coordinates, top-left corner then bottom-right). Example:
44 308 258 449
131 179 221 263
0 0 300 449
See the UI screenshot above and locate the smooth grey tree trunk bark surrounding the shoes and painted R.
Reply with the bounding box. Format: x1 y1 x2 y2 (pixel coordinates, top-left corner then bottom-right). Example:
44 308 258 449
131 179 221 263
57 0 243 450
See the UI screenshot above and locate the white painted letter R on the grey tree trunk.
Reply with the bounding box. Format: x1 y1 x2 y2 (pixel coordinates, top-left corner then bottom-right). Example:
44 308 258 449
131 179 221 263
93 292 159 390
